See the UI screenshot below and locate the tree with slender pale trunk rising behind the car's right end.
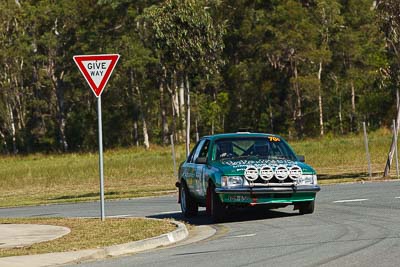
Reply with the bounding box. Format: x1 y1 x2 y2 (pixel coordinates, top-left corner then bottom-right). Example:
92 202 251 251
263 0 318 136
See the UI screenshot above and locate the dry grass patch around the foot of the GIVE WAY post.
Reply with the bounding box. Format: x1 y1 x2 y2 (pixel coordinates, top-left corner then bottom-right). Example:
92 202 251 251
0 218 176 257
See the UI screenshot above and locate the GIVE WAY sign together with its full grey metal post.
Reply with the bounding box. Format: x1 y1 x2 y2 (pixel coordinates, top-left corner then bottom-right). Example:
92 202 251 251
73 54 120 221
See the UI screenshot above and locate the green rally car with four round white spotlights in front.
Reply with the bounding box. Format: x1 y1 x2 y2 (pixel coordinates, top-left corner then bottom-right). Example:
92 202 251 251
176 133 320 222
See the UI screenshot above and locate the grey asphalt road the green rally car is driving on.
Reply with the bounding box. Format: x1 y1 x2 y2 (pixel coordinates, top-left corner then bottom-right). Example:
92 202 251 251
0 181 400 267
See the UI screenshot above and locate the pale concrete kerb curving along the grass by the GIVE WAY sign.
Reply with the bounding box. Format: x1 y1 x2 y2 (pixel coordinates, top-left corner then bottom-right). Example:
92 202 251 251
0 221 189 267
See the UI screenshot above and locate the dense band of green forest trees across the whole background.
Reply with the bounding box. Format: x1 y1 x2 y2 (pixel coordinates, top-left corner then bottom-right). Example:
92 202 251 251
0 0 400 153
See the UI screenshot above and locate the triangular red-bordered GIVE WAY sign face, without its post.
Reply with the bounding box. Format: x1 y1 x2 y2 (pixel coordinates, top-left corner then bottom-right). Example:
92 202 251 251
74 54 119 97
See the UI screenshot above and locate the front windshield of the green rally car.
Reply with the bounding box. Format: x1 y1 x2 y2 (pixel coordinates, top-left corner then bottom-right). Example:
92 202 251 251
213 136 297 160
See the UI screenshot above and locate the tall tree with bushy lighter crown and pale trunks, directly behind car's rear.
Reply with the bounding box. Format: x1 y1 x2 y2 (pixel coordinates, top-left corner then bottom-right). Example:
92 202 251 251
144 0 224 153
